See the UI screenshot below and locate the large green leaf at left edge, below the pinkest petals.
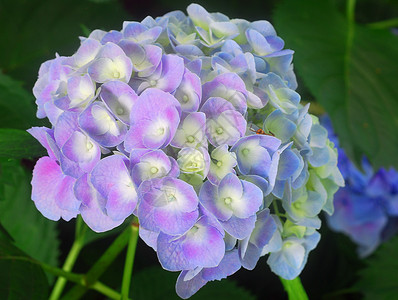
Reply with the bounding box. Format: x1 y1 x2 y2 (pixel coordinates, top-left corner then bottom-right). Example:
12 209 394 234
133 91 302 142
0 159 59 278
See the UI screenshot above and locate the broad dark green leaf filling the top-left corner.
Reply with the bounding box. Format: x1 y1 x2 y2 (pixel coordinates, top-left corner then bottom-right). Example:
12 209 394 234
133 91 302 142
0 0 130 86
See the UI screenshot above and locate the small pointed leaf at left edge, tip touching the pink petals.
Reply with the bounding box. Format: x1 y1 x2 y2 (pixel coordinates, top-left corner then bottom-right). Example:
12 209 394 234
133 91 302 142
0 128 46 159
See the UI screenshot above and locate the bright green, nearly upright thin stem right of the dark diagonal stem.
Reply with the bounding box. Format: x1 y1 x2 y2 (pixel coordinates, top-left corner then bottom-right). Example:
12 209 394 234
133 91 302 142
121 218 138 300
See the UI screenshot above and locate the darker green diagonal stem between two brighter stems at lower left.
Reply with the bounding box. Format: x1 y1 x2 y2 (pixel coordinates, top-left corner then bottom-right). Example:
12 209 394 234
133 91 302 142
62 221 131 300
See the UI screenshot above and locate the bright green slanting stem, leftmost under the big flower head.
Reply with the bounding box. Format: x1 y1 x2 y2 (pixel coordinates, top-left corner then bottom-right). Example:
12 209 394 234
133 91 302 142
49 215 85 300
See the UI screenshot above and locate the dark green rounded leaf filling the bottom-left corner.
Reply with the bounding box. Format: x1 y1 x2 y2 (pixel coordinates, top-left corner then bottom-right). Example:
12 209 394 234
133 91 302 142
0 239 49 300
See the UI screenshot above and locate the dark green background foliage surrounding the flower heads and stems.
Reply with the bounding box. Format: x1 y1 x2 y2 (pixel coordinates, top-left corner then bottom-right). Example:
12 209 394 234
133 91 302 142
0 0 398 299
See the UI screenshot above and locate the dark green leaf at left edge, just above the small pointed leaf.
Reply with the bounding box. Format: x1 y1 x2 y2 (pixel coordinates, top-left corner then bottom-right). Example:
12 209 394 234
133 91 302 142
0 73 43 129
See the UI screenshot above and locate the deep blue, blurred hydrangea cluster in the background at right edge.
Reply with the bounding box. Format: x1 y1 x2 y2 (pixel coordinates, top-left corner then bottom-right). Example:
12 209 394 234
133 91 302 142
322 117 398 257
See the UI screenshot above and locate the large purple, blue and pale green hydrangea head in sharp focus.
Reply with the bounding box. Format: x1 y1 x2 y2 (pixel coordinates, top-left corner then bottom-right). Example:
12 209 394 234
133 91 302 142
29 4 344 298
